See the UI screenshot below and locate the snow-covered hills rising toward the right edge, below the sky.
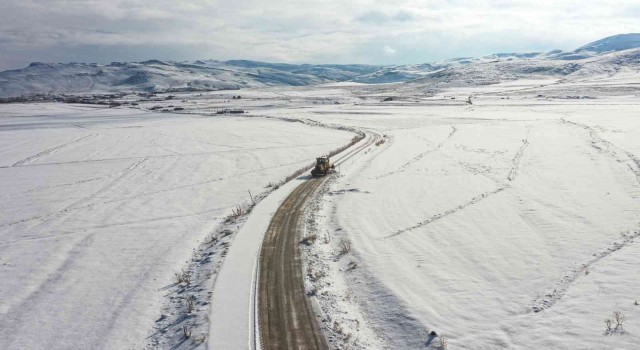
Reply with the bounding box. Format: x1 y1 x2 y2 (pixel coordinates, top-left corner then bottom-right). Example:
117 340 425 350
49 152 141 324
354 34 640 86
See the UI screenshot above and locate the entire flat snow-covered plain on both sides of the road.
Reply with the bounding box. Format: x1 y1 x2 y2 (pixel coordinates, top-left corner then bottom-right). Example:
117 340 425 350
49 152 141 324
0 71 640 349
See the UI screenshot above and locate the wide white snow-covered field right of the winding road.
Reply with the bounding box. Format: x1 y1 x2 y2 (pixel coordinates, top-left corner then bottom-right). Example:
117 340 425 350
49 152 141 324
273 83 640 349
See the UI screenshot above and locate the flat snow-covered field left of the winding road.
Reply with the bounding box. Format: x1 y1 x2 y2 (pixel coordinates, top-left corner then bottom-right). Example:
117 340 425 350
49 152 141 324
0 104 353 349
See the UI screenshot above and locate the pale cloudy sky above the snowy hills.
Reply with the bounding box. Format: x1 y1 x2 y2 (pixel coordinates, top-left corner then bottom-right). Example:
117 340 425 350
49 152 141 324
0 0 640 70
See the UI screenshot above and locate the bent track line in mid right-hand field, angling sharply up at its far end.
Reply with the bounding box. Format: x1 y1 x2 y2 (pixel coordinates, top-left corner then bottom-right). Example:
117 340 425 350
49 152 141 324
382 132 529 239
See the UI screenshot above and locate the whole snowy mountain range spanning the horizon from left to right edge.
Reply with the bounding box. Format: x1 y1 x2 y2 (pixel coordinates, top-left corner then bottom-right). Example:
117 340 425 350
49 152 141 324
0 34 640 97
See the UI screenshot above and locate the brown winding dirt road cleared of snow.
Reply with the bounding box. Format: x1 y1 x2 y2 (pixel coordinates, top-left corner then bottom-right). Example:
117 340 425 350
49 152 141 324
256 134 381 349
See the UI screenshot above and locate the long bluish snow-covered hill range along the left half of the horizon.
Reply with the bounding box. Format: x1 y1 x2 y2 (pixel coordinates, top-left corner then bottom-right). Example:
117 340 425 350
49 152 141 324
0 60 379 97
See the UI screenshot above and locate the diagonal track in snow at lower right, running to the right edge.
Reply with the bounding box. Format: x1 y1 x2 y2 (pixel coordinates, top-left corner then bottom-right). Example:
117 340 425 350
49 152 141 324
527 225 640 313
